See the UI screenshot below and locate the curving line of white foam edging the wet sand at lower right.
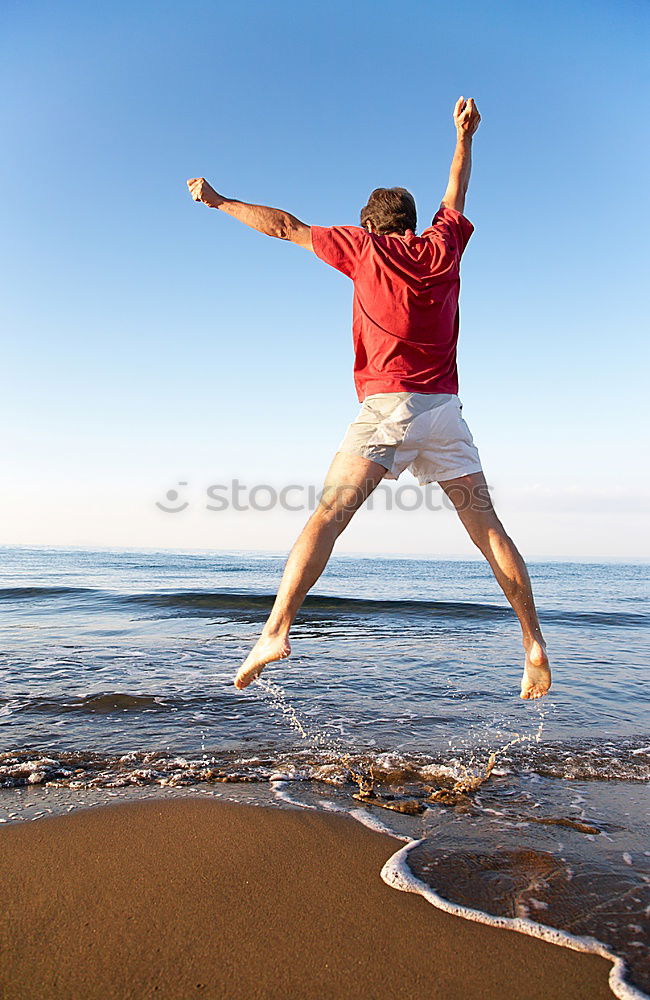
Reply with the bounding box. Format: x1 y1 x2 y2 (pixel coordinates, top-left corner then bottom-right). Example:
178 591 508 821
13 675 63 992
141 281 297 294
381 840 648 1000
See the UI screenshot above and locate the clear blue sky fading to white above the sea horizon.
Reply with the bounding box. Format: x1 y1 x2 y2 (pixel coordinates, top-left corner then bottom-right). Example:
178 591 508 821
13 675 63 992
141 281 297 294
0 0 650 559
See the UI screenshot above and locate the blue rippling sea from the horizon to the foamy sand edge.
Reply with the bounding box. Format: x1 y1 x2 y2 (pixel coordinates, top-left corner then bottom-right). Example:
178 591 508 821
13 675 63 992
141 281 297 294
0 547 650 998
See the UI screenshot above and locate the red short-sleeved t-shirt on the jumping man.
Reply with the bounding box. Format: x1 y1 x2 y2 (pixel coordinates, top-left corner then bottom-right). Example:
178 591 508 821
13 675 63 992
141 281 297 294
311 208 474 400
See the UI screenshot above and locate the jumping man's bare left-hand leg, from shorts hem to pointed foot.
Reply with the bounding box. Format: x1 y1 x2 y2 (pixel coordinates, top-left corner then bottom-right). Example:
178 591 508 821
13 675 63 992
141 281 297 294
235 452 386 688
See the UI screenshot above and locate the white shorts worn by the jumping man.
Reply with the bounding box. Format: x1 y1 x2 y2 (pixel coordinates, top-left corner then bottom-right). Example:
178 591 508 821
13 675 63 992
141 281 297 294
338 392 481 486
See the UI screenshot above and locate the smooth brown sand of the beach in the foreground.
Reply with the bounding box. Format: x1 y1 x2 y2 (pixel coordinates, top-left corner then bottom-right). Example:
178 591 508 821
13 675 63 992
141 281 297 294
0 798 612 1000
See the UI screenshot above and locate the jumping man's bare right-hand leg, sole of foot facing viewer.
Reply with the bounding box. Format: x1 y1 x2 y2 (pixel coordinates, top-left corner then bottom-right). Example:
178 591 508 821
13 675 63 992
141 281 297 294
440 472 551 698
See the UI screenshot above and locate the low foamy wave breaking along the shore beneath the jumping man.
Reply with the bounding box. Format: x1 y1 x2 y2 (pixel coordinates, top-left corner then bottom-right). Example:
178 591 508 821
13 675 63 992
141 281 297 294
0 736 650 788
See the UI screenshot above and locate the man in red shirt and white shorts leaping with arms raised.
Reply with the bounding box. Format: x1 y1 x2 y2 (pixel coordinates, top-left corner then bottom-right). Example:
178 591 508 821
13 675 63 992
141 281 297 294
187 97 551 698
